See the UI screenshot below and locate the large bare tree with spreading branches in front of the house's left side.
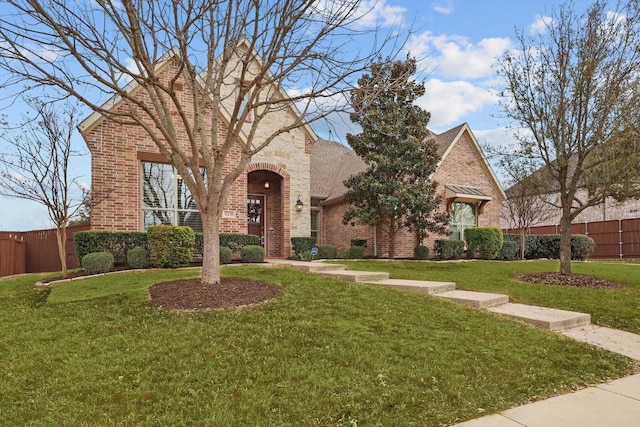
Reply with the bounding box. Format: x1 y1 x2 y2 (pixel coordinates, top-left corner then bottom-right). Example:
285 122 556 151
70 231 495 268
0 0 402 284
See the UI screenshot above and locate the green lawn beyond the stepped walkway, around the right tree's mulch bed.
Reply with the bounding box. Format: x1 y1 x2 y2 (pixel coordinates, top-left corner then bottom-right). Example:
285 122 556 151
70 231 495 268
341 260 640 334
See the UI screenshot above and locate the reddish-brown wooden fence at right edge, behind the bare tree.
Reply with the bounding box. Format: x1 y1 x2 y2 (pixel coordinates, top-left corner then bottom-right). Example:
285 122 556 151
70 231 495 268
506 218 640 259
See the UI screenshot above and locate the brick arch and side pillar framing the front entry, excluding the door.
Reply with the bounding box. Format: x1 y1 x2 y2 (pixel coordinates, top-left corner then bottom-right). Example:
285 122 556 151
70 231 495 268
247 162 291 258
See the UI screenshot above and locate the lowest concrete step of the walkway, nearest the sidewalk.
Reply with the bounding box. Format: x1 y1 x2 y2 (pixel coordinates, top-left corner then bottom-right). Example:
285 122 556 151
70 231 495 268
487 303 591 331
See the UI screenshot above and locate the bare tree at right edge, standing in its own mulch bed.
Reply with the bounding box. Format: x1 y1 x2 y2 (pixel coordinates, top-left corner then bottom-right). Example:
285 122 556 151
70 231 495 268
499 0 640 274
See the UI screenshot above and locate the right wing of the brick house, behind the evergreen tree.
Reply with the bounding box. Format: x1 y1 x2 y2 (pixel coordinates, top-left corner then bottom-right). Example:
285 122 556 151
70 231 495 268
311 123 506 257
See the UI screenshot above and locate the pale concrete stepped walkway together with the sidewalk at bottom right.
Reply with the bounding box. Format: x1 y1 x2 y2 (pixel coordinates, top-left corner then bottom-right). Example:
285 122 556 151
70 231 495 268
269 260 640 427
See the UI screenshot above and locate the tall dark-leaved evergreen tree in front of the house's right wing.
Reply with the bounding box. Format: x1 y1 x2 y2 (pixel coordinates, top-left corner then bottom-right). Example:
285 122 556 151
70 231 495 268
343 57 447 258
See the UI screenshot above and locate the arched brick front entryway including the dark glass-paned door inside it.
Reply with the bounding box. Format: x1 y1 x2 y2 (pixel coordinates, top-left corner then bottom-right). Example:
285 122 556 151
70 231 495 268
247 164 290 258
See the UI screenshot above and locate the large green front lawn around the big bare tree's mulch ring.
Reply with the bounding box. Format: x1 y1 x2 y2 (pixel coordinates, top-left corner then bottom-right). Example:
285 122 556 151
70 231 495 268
0 264 634 426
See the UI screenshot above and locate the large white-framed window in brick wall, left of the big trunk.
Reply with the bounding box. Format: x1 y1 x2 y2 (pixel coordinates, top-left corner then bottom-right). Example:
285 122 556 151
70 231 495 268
142 162 204 232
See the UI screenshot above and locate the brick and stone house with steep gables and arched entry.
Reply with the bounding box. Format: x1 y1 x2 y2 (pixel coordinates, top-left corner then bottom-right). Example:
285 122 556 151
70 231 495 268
79 51 505 258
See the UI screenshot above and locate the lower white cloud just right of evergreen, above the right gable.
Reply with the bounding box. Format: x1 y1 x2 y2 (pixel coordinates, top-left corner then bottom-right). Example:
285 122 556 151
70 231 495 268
416 79 498 128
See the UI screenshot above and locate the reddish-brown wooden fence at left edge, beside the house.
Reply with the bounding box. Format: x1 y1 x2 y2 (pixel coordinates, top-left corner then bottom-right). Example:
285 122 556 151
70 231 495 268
0 225 91 277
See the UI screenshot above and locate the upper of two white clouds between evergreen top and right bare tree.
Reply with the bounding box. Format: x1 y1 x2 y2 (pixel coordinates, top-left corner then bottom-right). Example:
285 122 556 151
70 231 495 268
407 31 511 79
